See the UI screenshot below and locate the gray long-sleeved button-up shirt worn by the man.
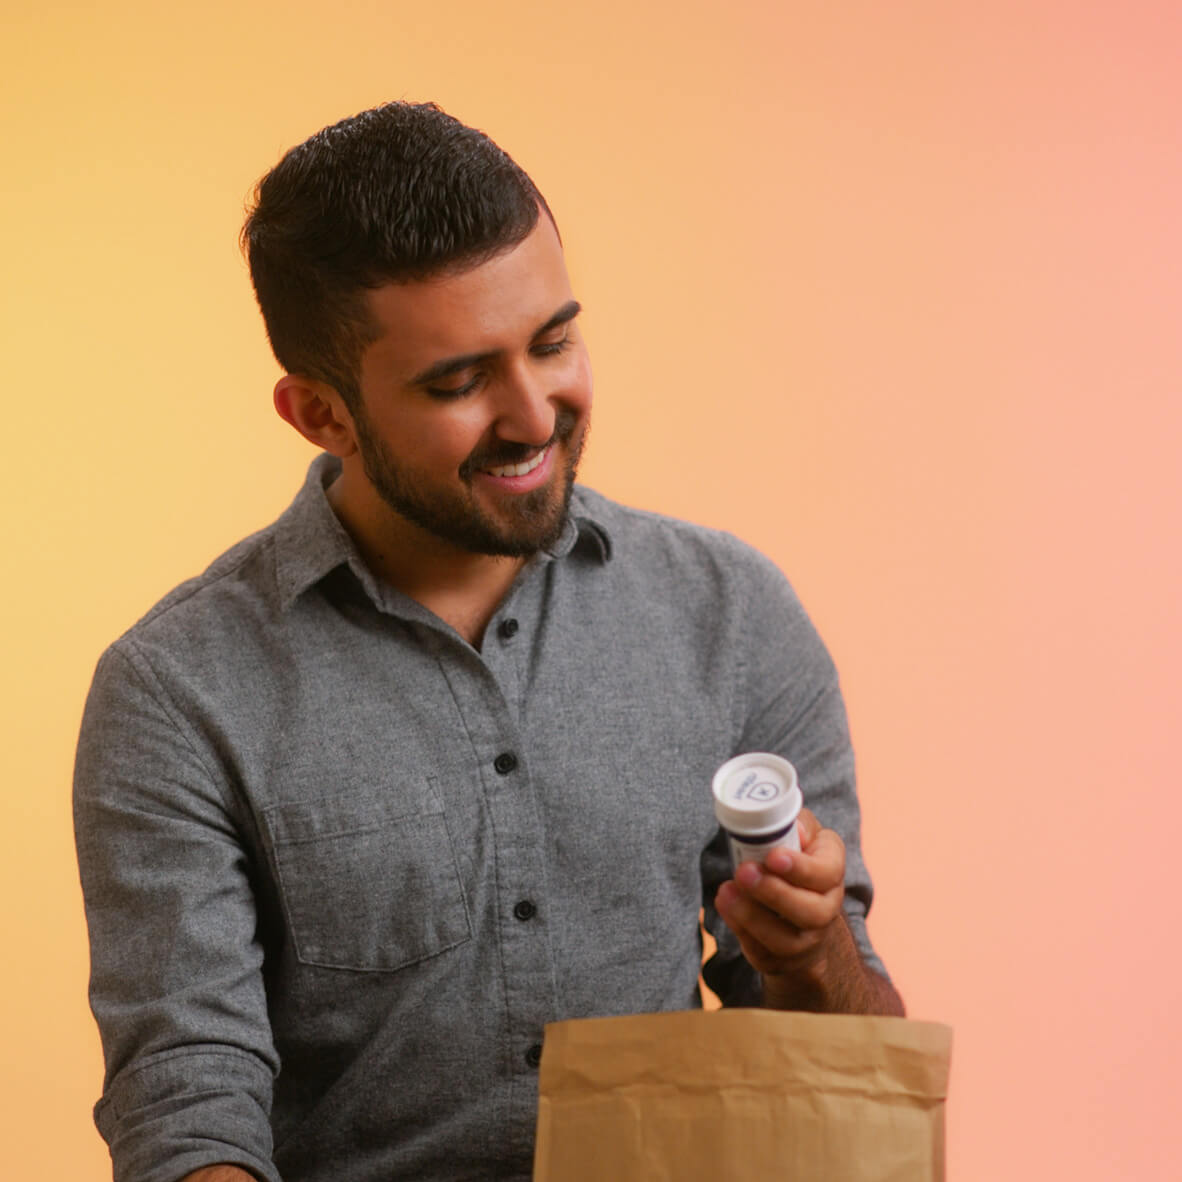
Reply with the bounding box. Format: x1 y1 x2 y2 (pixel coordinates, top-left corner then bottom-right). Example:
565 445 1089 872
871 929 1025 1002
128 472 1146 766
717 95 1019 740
74 456 882 1182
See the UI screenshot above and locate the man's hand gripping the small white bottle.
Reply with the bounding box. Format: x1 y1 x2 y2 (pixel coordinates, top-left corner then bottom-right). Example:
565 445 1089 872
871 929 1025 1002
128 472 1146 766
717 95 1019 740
715 808 845 989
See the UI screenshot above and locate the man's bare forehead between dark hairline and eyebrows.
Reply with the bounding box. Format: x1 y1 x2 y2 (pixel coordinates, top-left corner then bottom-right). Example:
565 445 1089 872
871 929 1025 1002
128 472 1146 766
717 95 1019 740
363 213 571 372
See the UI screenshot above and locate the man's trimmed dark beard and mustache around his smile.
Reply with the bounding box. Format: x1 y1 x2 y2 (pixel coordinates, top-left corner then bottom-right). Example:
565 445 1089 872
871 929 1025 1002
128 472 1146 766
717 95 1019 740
353 409 586 558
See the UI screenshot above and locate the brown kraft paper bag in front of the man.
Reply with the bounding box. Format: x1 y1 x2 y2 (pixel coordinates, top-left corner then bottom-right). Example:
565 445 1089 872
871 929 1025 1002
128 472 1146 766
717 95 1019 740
533 1009 952 1182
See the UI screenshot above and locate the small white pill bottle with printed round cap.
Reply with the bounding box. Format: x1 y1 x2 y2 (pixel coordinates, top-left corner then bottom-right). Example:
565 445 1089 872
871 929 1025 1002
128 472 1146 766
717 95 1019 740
714 752 803 866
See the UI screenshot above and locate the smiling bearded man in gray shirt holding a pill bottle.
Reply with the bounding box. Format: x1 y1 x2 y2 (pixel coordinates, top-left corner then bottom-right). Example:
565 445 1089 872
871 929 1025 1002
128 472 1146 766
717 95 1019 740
76 104 902 1182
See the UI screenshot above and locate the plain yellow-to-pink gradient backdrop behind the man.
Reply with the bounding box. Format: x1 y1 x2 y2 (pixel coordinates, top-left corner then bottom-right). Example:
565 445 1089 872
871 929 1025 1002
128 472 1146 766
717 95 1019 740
0 0 1182 1182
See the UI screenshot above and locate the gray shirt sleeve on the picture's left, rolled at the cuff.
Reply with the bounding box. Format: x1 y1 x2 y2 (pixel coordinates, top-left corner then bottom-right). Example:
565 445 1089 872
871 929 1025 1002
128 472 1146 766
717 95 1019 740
74 639 279 1182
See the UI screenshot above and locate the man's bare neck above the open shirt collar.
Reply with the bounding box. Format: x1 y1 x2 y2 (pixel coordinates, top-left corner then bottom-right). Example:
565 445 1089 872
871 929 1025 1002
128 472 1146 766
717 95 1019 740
327 463 526 649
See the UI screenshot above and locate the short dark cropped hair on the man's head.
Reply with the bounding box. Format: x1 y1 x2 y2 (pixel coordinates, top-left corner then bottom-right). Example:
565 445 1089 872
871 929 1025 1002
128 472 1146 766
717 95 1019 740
241 103 550 411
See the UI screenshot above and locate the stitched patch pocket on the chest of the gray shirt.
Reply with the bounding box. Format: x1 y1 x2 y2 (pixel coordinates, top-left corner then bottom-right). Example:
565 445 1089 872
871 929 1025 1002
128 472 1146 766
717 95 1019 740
264 779 472 972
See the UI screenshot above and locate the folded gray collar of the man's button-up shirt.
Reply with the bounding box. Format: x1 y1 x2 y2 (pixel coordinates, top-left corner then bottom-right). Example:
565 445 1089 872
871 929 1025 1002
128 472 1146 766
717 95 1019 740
274 453 611 610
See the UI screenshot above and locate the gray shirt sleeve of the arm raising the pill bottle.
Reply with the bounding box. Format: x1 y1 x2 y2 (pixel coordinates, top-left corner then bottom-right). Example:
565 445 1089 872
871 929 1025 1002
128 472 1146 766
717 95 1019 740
702 544 889 1005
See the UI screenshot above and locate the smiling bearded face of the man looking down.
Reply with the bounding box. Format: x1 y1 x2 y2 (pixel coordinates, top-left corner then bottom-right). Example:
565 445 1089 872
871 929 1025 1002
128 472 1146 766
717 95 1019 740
353 213 591 557
